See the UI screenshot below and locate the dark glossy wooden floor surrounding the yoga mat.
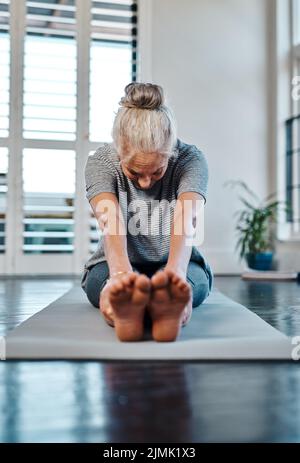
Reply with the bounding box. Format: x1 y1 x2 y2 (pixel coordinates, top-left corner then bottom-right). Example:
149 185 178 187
0 277 300 443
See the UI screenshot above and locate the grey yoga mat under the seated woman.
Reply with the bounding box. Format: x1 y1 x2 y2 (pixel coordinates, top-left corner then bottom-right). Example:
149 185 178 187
6 287 292 360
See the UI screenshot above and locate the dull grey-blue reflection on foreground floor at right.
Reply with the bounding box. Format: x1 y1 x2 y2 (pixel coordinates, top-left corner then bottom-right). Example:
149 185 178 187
186 362 300 442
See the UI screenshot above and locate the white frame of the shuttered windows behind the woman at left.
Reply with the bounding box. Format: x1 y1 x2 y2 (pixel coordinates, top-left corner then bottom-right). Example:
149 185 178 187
0 0 139 274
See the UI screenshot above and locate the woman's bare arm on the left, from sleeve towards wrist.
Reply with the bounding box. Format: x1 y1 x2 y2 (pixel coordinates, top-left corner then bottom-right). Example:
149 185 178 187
90 193 132 275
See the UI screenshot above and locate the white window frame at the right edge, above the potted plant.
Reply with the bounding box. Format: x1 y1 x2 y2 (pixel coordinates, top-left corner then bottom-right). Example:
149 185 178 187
276 0 300 242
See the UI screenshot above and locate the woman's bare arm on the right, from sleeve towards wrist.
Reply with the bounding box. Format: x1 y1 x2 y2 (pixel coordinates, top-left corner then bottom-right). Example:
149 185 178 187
166 192 204 278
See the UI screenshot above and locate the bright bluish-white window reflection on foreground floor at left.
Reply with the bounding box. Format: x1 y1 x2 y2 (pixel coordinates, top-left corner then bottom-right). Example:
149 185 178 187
0 362 105 442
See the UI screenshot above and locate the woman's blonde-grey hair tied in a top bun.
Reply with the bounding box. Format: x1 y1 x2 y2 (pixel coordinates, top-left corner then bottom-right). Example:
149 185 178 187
112 82 177 157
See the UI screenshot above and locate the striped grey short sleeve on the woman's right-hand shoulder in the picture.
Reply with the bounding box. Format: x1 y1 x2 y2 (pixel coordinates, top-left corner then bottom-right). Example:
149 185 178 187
177 146 208 202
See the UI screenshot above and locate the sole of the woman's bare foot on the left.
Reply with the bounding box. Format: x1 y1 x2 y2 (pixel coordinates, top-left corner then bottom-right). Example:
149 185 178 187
107 273 151 342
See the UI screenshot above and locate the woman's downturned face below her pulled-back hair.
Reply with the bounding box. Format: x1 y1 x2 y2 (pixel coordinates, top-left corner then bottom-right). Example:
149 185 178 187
121 153 168 190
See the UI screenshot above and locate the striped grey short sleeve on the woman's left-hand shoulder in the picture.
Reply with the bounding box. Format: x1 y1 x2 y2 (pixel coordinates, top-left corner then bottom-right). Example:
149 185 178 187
84 148 117 201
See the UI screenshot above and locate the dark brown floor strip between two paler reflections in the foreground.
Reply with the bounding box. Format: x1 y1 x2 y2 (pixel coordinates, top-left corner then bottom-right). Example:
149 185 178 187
99 362 193 442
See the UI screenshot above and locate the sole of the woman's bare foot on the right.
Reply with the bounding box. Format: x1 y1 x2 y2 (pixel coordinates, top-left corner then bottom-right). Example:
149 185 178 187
148 270 191 341
